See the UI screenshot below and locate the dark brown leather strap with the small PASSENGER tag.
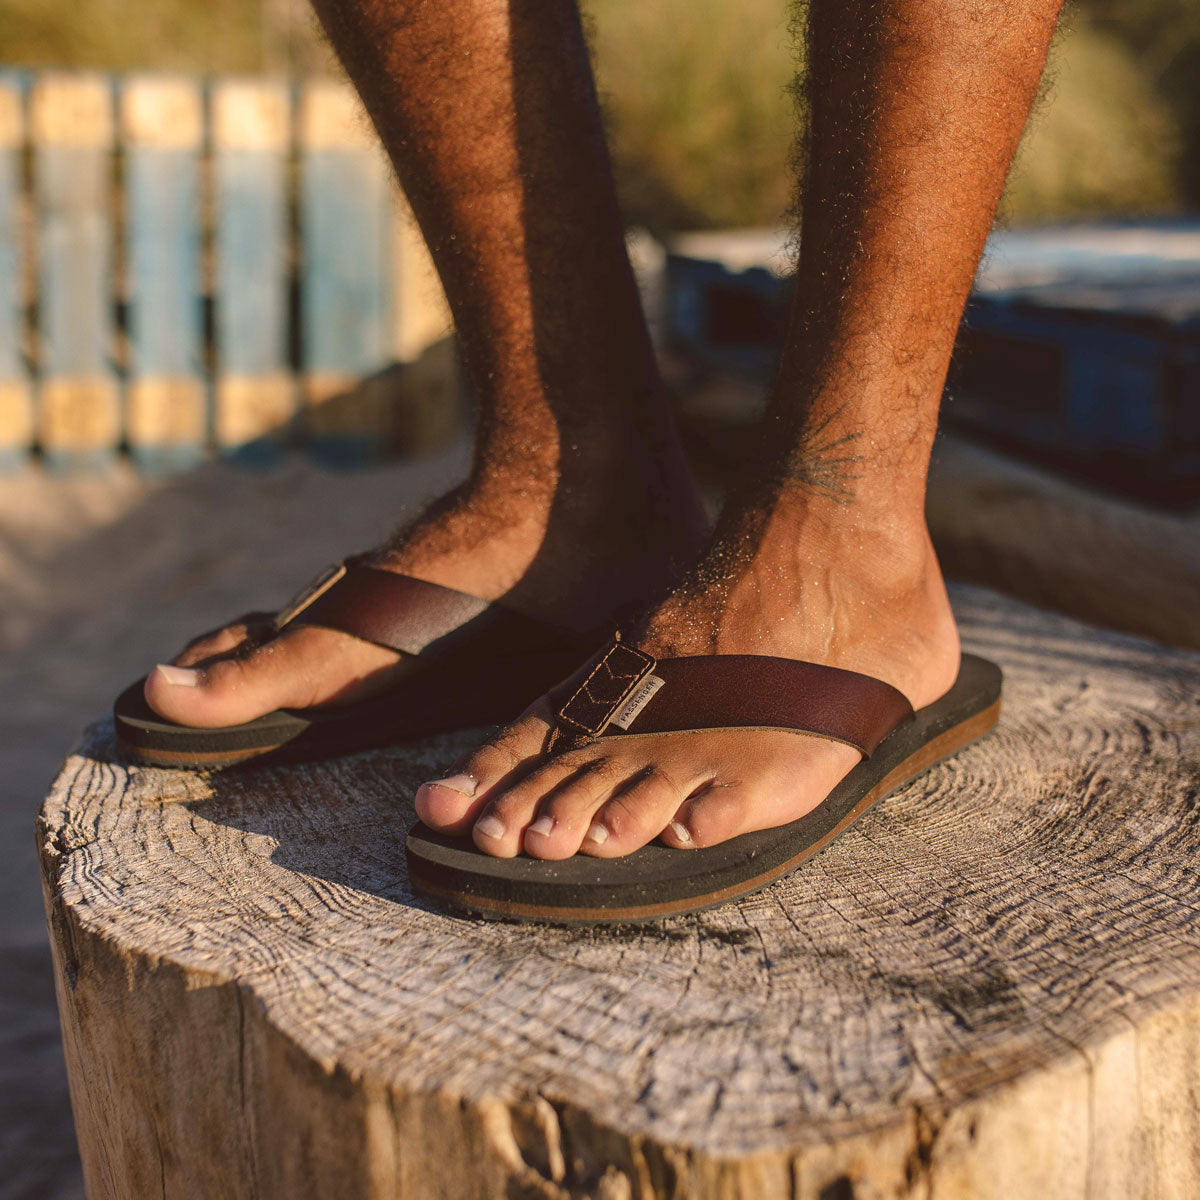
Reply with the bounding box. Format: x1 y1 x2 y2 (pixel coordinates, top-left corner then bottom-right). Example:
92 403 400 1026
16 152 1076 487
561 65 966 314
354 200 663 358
556 638 913 757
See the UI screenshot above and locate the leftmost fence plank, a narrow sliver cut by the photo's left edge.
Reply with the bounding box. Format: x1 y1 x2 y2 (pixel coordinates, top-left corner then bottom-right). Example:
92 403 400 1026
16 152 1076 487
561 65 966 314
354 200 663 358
0 72 34 473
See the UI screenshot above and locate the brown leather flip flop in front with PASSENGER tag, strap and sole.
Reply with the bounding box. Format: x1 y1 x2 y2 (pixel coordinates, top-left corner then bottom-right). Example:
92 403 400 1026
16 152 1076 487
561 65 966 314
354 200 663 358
406 637 1001 924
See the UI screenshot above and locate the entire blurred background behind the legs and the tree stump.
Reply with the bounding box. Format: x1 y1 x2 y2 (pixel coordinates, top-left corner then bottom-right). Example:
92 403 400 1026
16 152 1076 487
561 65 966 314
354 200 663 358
0 0 1200 1200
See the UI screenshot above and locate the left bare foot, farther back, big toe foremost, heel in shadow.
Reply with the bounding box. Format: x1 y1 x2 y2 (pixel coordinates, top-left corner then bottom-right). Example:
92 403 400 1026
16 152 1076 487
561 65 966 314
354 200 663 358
145 450 707 727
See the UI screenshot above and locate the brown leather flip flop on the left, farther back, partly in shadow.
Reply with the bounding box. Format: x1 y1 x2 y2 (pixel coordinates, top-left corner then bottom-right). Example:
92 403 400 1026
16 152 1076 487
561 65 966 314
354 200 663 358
113 556 600 768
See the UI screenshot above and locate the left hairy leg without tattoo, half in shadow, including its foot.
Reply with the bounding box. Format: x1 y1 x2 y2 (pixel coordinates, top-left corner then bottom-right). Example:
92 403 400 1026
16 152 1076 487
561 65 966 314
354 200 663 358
146 0 706 725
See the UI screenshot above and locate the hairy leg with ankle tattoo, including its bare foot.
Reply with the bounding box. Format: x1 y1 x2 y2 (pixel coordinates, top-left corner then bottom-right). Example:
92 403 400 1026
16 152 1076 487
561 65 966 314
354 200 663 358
418 0 1060 858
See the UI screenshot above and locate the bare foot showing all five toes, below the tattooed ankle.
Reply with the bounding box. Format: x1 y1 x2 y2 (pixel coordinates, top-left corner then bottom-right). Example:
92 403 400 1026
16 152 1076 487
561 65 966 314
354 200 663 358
416 501 959 859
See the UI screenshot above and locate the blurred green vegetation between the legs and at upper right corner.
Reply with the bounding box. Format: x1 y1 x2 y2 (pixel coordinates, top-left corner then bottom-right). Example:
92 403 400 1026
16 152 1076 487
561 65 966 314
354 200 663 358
587 0 1200 228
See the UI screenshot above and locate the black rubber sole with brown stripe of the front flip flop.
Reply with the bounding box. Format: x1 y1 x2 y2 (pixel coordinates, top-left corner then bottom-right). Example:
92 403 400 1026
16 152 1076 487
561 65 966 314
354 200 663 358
404 654 1002 925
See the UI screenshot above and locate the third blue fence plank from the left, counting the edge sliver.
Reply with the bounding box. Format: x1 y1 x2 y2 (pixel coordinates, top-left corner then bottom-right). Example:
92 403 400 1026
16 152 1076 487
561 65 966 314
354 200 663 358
120 76 209 473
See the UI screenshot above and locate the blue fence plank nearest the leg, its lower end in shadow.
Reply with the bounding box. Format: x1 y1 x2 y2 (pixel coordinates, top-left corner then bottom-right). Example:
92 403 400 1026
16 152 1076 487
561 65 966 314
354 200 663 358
300 82 395 466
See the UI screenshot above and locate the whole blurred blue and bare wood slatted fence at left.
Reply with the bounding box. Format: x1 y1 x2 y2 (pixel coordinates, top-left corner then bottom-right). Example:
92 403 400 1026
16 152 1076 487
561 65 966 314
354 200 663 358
0 71 456 470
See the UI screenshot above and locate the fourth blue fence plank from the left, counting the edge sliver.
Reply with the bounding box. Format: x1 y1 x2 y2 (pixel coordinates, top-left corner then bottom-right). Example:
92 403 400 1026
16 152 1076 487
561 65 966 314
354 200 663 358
211 79 295 466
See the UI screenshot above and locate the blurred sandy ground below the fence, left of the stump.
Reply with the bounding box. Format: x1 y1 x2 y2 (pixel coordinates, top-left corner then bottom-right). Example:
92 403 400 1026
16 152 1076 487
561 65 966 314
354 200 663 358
0 445 467 1200
